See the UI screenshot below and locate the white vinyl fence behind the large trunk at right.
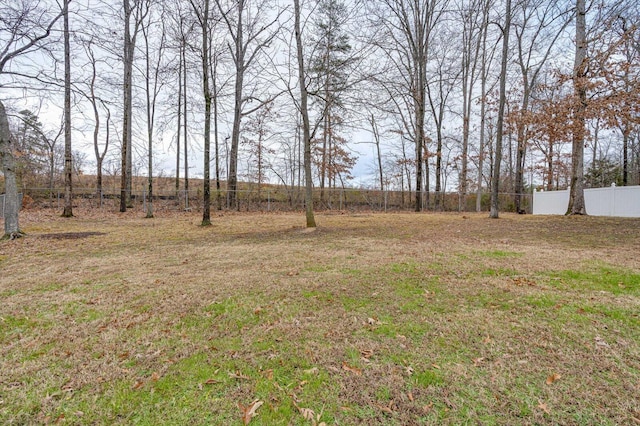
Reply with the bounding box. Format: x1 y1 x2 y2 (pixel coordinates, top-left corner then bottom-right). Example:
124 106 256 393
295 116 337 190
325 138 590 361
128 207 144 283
533 186 640 217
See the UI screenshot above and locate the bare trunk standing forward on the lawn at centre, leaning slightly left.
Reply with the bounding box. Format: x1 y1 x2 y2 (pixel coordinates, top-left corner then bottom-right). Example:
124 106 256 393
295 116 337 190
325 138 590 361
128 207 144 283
293 0 316 228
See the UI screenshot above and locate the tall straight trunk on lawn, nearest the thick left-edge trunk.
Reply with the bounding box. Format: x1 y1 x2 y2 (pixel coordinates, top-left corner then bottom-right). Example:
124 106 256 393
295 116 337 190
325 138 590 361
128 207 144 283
62 0 73 217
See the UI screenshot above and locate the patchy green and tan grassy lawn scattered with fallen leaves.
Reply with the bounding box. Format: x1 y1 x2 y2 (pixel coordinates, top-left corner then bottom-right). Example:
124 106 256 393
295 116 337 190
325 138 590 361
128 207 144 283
0 211 640 425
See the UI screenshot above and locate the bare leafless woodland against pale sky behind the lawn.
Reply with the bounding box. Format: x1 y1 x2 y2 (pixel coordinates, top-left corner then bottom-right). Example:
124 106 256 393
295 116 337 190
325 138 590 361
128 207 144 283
0 0 640 234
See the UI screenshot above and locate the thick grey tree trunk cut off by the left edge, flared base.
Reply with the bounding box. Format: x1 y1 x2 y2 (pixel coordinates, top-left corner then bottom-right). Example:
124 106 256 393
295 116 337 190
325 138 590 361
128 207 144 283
0 101 20 238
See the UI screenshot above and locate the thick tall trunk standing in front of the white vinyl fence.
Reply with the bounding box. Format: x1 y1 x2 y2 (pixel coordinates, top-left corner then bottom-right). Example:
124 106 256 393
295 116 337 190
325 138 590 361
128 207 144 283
567 0 587 215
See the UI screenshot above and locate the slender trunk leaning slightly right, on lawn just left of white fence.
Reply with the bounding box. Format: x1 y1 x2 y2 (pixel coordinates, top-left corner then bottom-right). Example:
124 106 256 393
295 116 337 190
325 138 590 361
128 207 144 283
489 0 511 219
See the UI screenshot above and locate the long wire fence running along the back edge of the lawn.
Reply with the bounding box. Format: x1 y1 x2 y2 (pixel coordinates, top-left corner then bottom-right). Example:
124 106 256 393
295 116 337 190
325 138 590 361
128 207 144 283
16 186 532 213
